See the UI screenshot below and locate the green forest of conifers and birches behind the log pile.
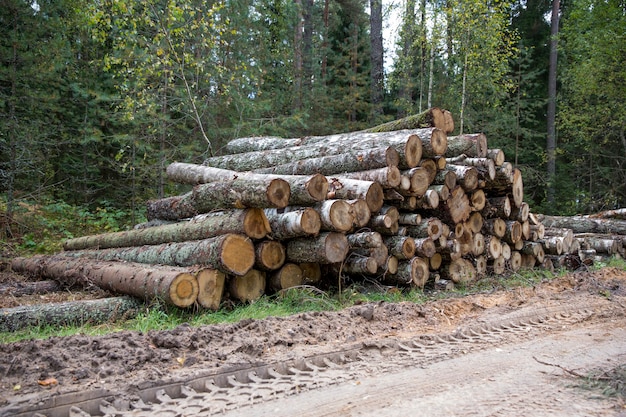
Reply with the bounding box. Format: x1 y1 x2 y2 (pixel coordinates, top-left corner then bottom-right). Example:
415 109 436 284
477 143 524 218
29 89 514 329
0 0 626 247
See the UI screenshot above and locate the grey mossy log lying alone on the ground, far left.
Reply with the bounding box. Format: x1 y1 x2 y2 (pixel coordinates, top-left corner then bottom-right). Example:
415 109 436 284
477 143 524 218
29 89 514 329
0 297 142 332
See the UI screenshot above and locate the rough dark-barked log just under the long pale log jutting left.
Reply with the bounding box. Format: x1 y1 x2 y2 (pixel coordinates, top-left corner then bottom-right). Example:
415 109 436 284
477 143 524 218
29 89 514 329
147 178 291 220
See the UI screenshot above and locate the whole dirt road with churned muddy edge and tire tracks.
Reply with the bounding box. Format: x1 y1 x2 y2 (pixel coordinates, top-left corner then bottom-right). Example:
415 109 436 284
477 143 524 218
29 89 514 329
0 268 626 417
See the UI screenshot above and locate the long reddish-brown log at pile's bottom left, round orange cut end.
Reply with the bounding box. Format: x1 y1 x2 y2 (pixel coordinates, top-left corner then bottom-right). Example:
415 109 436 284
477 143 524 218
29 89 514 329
11 255 198 308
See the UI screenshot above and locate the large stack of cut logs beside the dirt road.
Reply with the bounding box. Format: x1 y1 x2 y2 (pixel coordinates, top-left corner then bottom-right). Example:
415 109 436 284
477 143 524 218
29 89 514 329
12 109 612 309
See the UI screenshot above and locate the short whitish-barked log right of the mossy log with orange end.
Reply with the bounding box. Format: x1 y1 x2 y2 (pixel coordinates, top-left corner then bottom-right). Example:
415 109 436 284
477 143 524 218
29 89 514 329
264 207 322 240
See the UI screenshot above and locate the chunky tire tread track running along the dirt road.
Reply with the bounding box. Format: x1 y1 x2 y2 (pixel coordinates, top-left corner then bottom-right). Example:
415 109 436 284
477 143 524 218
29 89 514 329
0 300 624 417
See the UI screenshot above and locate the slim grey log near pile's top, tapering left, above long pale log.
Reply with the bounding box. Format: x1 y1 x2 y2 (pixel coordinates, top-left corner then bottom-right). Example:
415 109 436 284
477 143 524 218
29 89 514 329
253 146 400 175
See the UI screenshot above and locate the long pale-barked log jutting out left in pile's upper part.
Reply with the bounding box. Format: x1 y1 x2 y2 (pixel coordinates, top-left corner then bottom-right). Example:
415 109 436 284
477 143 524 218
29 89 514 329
166 162 328 205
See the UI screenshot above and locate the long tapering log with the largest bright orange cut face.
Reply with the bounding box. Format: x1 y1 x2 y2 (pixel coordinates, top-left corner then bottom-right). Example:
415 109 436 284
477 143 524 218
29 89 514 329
63 233 254 275
